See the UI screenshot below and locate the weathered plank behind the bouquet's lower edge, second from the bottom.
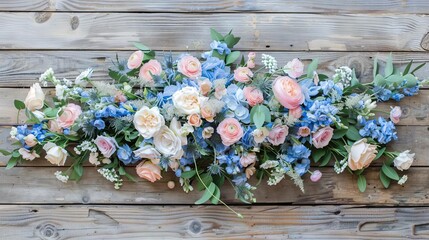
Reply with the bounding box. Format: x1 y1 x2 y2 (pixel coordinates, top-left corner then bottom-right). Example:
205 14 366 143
0 167 422 206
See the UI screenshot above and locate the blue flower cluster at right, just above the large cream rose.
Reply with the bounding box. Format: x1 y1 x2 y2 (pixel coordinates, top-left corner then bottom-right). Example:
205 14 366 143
358 117 398 144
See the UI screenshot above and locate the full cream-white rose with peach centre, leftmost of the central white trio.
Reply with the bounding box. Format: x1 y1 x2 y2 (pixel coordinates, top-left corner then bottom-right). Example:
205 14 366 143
134 106 165 139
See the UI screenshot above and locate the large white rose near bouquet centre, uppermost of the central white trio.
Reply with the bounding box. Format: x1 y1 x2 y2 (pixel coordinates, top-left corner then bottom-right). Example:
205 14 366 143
173 87 201 115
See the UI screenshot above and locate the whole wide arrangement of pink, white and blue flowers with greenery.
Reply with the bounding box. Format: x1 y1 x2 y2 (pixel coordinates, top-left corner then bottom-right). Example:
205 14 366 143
1 29 425 217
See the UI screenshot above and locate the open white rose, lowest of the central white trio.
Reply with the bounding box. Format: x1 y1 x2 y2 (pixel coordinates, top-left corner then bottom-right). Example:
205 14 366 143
153 126 183 159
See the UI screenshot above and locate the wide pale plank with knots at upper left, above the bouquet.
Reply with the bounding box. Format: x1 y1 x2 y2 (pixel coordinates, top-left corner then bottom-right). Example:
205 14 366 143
0 12 429 51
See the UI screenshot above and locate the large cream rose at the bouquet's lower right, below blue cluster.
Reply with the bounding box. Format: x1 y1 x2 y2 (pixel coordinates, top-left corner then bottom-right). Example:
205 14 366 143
348 138 377 171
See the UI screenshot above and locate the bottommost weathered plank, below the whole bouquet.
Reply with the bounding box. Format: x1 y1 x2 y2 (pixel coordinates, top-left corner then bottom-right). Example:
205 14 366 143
0 205 429 240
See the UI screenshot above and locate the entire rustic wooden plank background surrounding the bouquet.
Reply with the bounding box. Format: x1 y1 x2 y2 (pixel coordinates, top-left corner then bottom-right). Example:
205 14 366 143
0 0 429 239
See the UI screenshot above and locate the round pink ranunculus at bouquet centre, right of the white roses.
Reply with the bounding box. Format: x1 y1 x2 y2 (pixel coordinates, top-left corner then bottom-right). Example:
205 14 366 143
216 118 243 146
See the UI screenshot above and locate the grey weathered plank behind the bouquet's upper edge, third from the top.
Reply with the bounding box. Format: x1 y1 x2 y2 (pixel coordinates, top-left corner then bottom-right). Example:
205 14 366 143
0 50 429 87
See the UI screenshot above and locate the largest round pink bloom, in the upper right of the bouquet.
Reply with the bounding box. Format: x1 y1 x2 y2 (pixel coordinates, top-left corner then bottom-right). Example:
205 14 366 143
273 77 305 109
